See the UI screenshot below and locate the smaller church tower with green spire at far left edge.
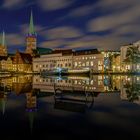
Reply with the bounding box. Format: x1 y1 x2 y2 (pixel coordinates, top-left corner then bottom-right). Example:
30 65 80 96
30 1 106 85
0 31 7 56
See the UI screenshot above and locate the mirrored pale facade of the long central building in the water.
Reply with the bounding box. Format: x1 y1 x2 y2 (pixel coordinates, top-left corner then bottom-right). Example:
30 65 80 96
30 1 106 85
33 75 120 92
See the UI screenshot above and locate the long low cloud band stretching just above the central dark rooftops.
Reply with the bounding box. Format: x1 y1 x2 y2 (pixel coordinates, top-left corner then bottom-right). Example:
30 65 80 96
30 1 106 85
39 34 139 50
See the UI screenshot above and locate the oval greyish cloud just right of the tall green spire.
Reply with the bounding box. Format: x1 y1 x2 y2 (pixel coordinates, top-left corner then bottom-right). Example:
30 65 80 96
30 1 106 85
46 26 83 39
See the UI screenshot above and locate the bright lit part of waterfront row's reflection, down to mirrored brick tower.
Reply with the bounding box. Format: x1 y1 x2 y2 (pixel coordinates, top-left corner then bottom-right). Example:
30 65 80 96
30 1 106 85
0 75 140 107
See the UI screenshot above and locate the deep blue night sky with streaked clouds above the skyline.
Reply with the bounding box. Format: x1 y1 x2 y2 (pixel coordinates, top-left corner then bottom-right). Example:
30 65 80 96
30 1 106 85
0 0 140 52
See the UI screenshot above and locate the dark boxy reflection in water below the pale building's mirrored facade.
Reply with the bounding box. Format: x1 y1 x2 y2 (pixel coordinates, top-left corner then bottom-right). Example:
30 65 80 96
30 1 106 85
54 86 94 113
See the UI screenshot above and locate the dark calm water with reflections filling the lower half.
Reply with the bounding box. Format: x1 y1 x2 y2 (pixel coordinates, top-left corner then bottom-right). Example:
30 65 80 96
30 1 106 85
0 75 140 139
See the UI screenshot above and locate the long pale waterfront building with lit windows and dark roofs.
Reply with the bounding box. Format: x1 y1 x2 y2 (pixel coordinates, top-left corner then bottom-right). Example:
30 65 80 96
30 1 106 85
33 50 104 72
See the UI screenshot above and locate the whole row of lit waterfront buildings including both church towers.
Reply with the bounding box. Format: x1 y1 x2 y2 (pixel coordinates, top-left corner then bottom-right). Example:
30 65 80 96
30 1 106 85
0 12 140 73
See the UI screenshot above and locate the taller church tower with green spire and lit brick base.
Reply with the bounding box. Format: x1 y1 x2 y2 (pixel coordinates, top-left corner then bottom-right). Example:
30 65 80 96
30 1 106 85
26 11 37 55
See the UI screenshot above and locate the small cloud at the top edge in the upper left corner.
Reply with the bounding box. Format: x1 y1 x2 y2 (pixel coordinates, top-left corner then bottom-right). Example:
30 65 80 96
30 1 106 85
2 0 26 9
